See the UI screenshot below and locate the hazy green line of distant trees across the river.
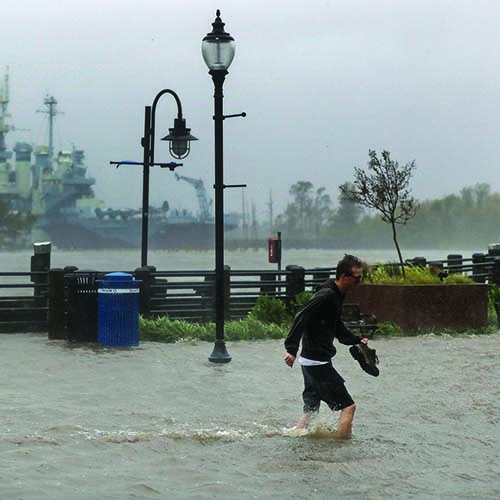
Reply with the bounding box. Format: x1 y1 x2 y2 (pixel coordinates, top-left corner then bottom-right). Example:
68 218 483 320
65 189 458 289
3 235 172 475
266 181 500 250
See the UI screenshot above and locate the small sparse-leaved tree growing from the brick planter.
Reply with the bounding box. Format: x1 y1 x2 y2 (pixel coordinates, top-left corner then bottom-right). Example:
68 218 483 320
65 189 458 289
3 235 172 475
339 150 418 276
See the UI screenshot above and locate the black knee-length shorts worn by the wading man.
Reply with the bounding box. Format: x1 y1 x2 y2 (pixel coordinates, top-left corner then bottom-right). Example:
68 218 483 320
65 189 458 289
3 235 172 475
302 363 354 413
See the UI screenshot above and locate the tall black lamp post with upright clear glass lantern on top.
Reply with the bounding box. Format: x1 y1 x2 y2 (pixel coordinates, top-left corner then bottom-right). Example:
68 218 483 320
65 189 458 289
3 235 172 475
201 10 246 363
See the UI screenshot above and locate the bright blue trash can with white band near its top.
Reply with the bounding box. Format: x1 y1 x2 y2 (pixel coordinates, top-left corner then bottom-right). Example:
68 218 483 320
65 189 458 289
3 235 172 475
97 273 141 347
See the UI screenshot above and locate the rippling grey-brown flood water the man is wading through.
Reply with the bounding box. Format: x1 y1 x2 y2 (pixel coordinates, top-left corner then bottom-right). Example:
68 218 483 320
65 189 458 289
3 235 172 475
0 334 500 500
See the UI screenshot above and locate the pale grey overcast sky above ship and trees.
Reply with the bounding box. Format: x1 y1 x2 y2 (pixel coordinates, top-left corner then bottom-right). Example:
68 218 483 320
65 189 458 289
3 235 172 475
0 0 500 218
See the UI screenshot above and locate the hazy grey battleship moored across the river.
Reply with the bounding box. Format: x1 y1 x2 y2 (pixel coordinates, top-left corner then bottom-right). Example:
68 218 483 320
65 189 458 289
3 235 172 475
0 73 238 250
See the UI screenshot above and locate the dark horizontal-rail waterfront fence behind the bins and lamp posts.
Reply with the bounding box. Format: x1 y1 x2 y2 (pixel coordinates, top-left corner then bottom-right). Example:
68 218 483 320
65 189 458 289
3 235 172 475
0 253 500 339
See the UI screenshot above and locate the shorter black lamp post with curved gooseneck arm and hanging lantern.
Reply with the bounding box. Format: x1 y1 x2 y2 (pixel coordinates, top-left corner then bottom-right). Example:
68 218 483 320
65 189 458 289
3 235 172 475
110 89 198 267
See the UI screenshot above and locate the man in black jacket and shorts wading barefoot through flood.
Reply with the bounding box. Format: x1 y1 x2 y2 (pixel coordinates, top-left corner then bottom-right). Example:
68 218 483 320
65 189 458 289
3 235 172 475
285 255 368 439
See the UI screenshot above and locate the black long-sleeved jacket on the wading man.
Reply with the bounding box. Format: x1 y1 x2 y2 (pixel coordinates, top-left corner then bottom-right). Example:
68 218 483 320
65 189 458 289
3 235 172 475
285 280 362 361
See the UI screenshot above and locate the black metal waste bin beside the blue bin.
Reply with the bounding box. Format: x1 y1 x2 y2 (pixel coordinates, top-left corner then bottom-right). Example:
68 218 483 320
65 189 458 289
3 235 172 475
65 270 102 342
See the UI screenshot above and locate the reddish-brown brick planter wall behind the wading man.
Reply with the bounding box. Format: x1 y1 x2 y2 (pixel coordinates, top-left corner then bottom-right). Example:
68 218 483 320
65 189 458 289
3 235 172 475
345 284 488 331
